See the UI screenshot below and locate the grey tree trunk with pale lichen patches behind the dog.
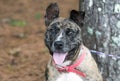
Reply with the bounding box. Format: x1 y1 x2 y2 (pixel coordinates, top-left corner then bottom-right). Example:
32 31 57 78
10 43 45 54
79 0 120 81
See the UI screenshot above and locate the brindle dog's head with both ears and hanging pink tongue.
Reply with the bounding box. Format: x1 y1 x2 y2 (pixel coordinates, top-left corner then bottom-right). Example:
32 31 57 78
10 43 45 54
45 3 85 64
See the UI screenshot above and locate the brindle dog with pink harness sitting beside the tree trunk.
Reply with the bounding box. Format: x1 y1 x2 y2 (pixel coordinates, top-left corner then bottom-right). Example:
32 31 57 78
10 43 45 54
45 3 103 81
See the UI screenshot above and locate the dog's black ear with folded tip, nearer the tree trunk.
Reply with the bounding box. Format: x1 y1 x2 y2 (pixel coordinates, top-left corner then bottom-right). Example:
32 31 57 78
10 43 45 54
70 10 85 27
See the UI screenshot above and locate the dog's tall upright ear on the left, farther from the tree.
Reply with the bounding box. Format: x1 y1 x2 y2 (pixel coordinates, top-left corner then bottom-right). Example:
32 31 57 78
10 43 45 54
45 3 59 26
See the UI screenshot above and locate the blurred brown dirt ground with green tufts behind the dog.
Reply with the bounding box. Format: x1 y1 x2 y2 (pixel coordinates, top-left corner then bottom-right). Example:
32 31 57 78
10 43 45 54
0 0 79 81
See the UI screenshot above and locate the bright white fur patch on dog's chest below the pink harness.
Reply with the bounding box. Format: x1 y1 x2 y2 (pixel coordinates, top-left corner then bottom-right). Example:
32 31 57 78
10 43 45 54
56 72 83 81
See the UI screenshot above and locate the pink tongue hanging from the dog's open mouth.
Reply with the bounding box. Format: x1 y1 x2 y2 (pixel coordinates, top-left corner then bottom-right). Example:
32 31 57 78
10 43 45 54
53 53 67 65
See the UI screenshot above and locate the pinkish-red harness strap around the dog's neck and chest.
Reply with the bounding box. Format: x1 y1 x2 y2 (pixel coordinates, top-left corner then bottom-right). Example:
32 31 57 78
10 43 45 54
54 48 86 77
